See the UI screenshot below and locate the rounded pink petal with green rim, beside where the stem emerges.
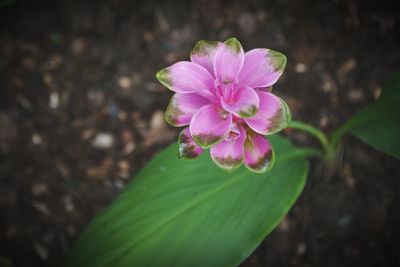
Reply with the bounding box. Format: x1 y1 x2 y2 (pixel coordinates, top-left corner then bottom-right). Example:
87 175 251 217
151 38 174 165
245 91 291 134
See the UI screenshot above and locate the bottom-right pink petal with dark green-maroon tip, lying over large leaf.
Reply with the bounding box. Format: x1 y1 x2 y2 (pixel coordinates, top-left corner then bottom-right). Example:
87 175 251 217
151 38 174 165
244 130 275 173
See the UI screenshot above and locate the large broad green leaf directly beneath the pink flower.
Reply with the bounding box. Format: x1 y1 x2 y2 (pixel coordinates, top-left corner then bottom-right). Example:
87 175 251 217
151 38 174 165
66 136 308 267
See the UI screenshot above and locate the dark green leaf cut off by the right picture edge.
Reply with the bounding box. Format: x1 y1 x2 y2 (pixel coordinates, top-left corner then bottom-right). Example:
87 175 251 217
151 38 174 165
337 72 400 159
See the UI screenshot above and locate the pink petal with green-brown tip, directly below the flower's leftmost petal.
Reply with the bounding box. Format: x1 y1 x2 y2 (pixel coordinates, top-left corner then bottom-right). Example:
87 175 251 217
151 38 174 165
165 93 210 127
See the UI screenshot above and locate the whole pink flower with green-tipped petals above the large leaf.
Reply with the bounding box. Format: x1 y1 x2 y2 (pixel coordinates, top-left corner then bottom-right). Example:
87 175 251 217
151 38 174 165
157 38 290 172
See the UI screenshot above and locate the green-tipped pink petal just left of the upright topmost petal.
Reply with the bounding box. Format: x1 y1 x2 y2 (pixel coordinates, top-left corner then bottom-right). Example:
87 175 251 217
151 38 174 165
190 40 220 76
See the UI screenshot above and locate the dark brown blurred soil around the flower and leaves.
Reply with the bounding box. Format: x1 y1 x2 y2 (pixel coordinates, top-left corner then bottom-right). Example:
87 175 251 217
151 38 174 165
0 0 400 267
